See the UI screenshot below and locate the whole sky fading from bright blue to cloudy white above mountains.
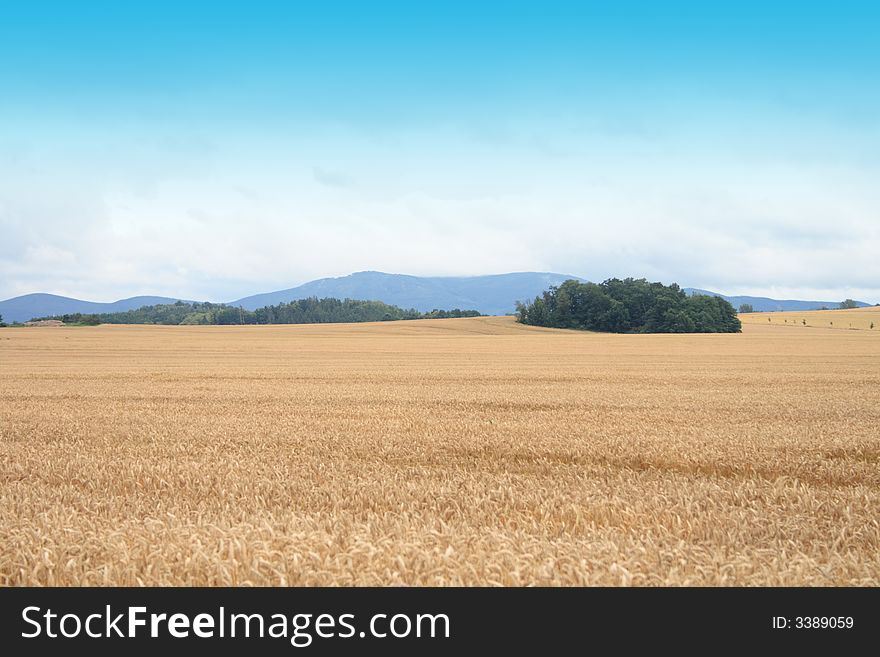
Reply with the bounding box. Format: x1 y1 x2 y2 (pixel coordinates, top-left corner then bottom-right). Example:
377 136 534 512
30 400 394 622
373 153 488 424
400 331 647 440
0 0 880 303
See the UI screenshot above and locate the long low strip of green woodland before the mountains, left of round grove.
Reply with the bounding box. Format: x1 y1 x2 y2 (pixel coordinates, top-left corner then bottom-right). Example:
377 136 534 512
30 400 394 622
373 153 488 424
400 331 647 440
41 297 480 325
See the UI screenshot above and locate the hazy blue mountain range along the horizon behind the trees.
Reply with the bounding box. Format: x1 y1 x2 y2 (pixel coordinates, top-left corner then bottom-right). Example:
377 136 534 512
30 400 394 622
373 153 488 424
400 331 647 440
0 271 870 322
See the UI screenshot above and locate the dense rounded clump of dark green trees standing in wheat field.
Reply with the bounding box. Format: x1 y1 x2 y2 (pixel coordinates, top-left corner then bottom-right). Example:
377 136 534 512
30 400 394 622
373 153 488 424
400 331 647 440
517 278 742 333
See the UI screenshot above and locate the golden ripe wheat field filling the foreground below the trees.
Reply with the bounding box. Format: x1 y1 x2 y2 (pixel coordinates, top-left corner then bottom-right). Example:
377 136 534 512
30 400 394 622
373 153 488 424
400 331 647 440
0 315 880 586
